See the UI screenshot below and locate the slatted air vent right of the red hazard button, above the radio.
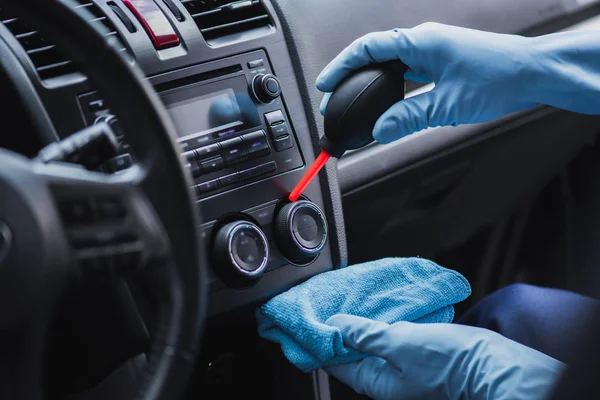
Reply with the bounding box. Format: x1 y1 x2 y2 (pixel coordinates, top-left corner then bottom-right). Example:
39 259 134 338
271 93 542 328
182 0 273 42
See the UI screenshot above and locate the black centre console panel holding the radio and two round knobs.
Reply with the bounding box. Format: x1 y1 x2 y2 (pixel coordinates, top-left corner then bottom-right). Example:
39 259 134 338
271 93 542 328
151 50 332 313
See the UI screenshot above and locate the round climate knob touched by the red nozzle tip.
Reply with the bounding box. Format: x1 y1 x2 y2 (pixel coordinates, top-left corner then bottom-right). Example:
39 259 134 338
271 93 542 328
275 200 327 264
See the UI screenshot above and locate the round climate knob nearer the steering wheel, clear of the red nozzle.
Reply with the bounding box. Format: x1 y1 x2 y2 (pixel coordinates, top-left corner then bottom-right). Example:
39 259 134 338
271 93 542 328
212 221 269 287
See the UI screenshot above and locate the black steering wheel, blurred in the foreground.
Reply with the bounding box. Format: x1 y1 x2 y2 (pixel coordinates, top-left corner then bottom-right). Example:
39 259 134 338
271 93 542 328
0 0 207 400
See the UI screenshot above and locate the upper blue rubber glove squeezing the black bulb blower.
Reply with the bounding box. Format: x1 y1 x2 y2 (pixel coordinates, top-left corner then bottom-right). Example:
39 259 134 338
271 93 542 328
317 23 600 143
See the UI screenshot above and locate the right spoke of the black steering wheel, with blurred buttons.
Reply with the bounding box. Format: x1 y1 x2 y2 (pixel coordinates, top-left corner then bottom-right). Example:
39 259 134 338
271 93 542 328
34 163 169 277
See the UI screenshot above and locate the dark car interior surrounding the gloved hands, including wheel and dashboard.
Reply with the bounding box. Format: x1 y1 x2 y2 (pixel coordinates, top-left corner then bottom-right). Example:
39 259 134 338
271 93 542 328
0 0 600 400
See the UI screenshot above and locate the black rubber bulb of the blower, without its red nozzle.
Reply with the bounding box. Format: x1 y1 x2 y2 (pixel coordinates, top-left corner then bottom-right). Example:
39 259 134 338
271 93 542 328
320 61 408 158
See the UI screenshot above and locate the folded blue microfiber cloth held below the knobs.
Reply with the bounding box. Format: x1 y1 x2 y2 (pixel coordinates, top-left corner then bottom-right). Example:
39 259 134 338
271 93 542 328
256 258 471 372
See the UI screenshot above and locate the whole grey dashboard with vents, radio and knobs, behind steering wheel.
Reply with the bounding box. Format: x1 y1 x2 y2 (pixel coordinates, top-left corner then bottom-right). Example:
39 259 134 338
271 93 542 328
0 0 598 315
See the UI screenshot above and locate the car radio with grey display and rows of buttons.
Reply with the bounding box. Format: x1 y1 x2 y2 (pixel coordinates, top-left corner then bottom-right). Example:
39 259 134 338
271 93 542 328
79 51 304 199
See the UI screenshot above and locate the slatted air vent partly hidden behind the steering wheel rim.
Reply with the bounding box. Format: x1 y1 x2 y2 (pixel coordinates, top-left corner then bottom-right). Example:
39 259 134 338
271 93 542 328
0 0 127 80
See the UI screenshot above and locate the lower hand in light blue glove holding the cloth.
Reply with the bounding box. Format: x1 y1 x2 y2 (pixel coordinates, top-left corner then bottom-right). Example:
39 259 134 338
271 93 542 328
325 315 565 400
